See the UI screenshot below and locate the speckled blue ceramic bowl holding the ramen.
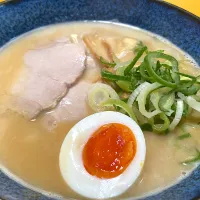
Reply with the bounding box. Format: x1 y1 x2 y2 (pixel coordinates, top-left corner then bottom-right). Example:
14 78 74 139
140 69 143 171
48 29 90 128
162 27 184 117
0 0 200 200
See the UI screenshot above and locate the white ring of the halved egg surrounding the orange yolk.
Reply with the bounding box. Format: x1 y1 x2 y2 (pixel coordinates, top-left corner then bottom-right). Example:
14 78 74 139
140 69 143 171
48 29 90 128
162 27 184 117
59 111 146 199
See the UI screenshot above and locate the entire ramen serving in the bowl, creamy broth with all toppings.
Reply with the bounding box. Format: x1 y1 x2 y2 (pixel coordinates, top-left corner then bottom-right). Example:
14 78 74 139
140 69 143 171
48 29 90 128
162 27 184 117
0 22 200 199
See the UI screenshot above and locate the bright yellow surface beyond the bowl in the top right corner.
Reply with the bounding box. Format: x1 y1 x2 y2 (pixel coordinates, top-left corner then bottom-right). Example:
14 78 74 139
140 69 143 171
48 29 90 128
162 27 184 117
164 0 200 17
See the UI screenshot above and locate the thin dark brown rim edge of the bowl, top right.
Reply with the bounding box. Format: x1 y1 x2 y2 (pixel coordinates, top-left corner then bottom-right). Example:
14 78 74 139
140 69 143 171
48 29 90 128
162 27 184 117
150 0 200 24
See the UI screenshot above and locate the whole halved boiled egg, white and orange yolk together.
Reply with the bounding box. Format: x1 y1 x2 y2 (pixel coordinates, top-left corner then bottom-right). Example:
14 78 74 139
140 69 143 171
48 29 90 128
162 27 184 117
59 111 146 199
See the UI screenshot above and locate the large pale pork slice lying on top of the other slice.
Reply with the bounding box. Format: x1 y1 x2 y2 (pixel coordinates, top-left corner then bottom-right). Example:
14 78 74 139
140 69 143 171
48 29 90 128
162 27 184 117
11 42 86 119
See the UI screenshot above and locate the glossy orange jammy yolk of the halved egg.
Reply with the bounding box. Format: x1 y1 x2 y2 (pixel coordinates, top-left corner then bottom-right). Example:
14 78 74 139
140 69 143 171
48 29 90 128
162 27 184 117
82 123 137 179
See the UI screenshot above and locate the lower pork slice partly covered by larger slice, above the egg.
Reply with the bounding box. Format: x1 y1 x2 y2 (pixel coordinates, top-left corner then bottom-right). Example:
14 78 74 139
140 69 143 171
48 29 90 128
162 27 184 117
42 81 92 130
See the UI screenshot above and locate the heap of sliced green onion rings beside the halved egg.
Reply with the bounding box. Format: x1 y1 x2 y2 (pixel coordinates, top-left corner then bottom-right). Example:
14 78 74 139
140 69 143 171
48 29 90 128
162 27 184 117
88 42 200 136
